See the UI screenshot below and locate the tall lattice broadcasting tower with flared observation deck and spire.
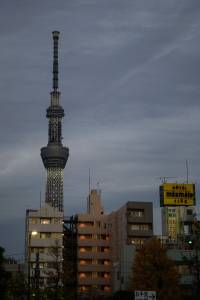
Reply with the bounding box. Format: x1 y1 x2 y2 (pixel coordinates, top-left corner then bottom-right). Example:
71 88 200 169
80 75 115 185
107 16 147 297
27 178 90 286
41 31 69 211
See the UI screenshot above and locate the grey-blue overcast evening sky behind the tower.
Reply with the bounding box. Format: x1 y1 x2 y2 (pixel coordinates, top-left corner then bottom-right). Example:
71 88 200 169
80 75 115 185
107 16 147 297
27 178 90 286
0 0 200 255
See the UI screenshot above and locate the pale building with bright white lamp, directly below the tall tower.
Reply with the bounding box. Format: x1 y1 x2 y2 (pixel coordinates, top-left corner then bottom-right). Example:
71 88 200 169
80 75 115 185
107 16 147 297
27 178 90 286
25 203 63 288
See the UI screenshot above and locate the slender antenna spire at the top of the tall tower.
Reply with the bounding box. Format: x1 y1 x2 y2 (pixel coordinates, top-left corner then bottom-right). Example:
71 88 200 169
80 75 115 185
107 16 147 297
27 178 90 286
52 31 60 92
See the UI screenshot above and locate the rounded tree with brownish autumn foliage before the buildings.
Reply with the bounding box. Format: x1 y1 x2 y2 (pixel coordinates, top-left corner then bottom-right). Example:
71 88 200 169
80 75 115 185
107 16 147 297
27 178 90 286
131 238 182 300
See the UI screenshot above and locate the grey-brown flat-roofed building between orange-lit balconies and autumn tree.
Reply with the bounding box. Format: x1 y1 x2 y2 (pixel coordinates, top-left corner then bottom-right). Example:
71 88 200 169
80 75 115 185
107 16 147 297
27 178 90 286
109 201 153 292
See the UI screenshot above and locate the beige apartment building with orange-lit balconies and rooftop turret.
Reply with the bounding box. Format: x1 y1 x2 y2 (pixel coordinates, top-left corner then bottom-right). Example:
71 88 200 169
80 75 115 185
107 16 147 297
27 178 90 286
77 190 112 297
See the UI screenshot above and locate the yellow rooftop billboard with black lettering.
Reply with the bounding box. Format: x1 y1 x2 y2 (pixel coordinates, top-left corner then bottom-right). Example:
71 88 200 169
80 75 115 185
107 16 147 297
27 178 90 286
160 183 196 206
